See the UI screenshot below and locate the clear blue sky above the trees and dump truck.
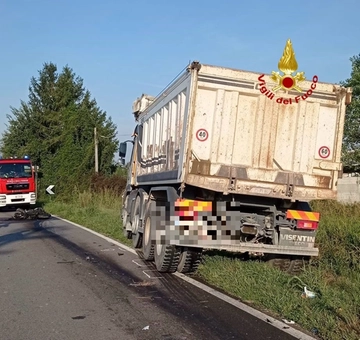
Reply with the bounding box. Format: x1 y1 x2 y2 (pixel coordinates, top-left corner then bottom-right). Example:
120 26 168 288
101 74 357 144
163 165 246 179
0 0 360 162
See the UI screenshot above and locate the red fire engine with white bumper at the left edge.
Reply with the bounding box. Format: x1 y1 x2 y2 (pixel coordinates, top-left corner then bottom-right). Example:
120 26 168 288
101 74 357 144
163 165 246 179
0 157 36 207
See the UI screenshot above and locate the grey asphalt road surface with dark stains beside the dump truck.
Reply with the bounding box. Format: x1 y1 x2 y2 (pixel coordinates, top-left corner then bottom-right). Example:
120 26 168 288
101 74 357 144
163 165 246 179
0 212 312 340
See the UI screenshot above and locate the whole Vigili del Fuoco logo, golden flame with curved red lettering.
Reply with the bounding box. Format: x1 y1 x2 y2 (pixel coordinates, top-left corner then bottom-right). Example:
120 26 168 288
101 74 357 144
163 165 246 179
258 39 318 105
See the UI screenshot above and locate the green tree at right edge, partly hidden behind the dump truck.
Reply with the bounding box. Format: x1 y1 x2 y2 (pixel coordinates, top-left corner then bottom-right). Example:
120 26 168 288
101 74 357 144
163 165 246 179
341 54 360 172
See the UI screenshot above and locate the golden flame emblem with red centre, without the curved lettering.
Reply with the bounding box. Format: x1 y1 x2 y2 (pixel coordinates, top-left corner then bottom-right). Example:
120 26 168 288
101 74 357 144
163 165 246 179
270 39 305 92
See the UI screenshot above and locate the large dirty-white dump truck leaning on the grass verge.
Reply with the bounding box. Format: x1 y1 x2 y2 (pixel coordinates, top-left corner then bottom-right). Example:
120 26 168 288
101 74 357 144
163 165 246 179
119 44 351 274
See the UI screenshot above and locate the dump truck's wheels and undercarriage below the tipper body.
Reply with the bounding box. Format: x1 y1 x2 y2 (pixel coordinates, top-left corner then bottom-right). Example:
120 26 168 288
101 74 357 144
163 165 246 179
121 186 318 274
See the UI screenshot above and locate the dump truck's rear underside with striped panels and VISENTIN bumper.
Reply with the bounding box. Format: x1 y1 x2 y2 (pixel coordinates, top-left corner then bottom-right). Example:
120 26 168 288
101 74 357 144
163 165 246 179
151 199 319 257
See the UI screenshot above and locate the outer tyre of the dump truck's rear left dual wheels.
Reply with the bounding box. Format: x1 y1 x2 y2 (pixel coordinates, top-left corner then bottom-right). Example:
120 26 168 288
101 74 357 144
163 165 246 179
154 244 181 273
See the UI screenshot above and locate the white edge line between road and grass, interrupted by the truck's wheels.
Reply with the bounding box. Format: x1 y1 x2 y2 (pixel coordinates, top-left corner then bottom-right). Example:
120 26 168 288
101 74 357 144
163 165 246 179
52 215 316 340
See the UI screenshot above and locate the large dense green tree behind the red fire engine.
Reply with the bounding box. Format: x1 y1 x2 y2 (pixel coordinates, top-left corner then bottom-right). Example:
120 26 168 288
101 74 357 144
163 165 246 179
1 63 118 191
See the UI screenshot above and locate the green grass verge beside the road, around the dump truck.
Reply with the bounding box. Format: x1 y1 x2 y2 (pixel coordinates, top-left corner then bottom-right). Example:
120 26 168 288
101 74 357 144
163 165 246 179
45 191 360 340
